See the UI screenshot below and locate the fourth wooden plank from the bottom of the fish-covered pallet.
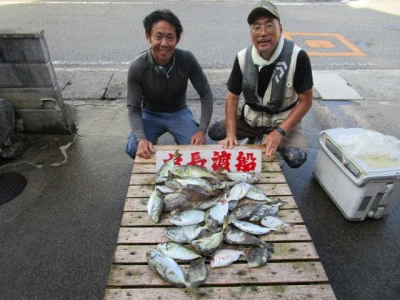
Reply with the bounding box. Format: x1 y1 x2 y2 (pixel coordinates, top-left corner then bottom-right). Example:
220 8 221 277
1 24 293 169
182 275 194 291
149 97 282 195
117 225 311 245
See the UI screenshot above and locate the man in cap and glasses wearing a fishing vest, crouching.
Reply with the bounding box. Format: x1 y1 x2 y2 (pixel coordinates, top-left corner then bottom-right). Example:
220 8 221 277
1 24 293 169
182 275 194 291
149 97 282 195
208 1 313 168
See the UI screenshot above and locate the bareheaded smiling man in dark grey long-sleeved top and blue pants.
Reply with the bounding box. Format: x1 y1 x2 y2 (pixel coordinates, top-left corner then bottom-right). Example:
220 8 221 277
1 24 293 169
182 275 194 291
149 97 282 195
125 10 213 158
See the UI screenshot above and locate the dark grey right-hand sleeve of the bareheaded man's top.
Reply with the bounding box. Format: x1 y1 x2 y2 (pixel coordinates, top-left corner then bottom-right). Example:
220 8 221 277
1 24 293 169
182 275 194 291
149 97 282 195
187 51 214 133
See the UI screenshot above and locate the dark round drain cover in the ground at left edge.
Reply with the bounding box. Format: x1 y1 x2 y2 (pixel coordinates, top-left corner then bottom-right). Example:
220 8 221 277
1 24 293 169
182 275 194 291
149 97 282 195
0 172 26 205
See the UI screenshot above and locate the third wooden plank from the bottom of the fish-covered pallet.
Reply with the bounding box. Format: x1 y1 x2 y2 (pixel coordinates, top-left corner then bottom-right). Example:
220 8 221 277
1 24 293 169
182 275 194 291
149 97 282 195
113 242 318 264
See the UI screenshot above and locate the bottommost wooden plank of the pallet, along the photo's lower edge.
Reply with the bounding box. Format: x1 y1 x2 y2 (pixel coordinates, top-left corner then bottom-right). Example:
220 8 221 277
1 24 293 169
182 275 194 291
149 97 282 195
104 284 336 300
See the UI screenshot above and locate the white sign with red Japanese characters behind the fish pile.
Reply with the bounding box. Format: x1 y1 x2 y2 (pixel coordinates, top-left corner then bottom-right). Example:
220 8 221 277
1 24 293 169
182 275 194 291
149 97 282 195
156 149 262 173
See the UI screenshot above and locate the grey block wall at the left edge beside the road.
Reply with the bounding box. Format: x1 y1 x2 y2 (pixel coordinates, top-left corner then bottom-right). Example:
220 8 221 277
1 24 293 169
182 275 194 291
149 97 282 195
0 31 75 134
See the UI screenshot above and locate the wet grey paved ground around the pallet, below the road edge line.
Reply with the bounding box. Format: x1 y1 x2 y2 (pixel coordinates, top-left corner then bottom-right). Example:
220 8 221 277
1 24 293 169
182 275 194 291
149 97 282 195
0 69 400 299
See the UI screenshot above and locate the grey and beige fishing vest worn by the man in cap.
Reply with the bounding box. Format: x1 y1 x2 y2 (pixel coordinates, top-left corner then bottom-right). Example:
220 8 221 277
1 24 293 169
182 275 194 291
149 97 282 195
238 39 301 127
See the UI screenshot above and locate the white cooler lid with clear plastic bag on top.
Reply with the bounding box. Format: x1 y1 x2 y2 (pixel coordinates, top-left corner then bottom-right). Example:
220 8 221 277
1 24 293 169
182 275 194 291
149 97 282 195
321 128 400 181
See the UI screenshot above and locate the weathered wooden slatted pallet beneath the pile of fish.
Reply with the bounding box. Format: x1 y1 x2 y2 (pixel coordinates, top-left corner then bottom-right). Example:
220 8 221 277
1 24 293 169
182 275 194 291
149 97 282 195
105 145 335 299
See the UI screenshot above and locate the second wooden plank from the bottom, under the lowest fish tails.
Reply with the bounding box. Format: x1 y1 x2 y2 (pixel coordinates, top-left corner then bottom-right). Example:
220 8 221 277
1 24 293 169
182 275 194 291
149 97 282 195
107 262 328 287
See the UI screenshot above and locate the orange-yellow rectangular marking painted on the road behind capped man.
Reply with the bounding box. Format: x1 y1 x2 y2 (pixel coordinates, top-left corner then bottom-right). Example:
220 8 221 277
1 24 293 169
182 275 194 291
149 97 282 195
284 32 366 56
